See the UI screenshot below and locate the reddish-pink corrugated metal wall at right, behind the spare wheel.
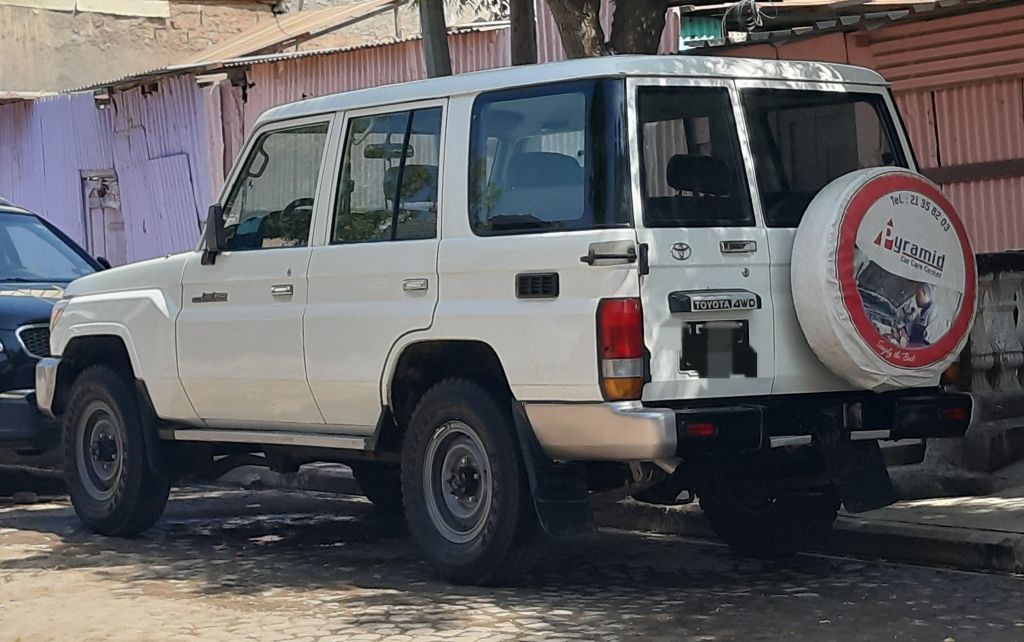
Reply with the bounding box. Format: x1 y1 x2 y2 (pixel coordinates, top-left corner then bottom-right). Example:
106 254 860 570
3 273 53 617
726 3 1024 252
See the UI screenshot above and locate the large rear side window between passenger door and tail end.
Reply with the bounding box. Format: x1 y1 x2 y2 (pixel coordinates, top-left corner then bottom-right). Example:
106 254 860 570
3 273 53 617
469 81 630 236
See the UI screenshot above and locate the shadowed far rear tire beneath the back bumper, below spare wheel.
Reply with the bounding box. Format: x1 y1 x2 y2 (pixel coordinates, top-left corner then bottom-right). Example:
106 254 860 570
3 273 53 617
700 487 840 558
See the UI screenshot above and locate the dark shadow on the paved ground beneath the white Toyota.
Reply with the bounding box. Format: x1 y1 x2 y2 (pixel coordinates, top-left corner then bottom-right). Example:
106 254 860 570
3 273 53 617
0 487 858 595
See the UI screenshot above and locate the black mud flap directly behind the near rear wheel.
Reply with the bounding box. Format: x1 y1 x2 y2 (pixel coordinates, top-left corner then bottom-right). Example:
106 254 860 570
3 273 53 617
512 402 596 540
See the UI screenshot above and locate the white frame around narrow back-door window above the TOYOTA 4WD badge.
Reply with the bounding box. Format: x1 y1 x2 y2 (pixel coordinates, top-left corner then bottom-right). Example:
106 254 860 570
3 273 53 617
629 78 762 229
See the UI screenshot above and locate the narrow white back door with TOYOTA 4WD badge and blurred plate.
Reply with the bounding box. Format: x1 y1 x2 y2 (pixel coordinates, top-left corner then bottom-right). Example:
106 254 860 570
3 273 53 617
628 79 774 400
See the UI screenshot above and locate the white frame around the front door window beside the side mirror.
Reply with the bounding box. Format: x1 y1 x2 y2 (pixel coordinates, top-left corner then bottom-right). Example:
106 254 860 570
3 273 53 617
205 114 336 254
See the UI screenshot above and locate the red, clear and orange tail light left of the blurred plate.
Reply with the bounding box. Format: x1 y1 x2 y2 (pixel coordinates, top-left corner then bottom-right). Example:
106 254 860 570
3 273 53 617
597 298 644 401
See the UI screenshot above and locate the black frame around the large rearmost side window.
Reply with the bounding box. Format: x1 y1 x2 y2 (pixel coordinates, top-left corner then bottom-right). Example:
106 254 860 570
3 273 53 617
464 77 634 238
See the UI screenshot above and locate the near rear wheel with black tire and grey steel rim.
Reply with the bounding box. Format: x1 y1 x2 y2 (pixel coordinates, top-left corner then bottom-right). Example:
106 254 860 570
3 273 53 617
401 379 537 586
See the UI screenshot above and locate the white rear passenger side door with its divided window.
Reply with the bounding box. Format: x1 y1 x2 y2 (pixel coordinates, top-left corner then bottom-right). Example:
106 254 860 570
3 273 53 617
303 100 446 435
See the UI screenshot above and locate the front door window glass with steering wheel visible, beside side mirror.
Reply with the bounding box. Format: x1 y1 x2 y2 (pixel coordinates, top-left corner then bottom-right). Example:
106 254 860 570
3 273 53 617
224 123 328 250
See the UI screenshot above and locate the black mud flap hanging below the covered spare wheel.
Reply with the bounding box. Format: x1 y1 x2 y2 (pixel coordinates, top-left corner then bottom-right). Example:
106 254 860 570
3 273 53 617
818 439 896 513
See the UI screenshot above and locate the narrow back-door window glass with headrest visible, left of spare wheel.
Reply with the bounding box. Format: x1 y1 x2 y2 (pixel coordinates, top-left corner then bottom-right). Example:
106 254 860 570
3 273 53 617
638 87 754 227
